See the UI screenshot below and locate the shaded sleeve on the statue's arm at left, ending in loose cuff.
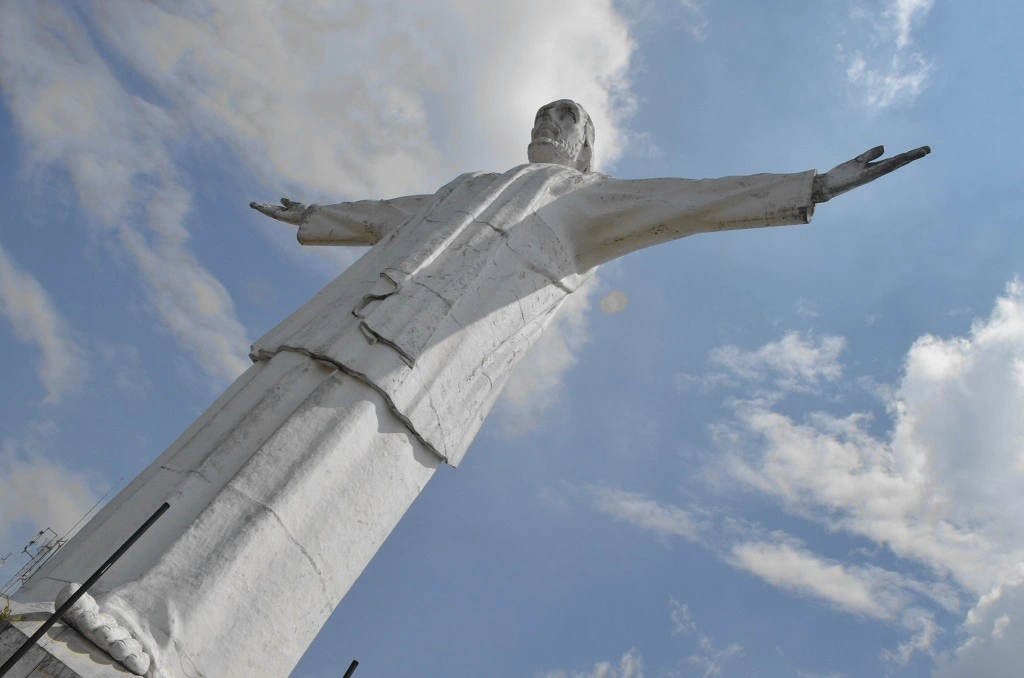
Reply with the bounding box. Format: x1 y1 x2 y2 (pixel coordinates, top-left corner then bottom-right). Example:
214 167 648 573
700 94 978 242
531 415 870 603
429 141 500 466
298 196 433 245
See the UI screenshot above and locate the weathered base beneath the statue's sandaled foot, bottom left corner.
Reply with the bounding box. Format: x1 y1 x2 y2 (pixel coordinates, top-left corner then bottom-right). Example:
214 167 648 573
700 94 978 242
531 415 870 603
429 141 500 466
0 600 136 678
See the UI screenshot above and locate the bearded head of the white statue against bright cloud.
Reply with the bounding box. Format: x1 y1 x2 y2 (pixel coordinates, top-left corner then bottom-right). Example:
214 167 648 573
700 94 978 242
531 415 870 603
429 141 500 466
526 99 594 172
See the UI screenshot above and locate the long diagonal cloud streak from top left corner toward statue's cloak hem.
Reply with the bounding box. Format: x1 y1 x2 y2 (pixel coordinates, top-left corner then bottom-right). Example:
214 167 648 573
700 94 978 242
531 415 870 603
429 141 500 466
0 2 247 387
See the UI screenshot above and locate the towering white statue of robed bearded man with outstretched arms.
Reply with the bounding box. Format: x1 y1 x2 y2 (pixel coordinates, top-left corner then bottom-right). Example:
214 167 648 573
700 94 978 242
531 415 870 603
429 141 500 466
18 100 929 678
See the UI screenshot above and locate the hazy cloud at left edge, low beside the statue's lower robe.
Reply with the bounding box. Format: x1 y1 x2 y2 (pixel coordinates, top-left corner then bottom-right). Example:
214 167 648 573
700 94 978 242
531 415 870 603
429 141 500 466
0 420 99 556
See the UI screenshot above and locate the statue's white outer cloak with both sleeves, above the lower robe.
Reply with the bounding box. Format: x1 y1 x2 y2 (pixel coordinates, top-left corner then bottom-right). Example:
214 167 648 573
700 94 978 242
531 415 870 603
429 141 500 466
252 164 814 466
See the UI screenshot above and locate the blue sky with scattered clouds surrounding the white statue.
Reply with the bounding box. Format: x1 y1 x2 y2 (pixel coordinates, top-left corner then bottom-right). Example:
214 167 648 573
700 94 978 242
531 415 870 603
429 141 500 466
0 0 1024 678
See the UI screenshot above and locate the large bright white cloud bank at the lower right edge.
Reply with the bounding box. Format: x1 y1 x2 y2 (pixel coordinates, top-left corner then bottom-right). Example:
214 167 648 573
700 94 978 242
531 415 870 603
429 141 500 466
717 280 1024 675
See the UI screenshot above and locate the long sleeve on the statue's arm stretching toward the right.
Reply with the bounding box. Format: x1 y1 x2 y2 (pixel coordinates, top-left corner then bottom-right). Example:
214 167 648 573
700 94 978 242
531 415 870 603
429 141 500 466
543 170 817 272
